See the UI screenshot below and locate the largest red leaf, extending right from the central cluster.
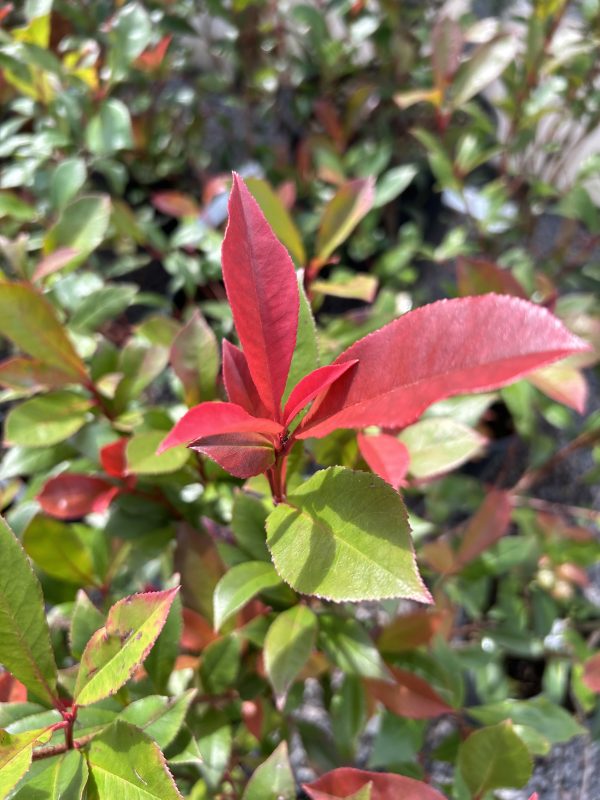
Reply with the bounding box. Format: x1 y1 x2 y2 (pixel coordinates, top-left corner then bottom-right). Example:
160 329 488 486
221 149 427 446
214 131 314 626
297 294 588 439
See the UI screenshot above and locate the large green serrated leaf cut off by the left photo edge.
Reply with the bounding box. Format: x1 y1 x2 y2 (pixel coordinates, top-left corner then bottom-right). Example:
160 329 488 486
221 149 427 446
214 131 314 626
0 518 56 705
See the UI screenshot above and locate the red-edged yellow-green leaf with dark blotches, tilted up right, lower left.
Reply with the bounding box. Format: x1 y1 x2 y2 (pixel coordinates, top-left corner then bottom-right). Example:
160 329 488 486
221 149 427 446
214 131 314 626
74 588 178 706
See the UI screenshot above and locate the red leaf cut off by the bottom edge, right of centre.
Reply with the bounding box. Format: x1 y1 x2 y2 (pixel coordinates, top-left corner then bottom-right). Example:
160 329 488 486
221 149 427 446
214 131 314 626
302 767 445 800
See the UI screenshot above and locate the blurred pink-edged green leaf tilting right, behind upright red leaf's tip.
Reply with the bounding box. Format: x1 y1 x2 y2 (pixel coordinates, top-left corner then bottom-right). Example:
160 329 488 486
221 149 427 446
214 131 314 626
316 178 375 263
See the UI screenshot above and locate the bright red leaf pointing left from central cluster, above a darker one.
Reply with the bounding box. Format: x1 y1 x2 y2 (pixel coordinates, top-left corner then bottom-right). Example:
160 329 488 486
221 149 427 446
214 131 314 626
157 402 283 453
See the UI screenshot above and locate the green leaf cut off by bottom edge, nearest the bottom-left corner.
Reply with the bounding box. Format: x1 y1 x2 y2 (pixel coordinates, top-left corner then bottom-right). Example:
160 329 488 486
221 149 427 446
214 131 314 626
11 750 88 800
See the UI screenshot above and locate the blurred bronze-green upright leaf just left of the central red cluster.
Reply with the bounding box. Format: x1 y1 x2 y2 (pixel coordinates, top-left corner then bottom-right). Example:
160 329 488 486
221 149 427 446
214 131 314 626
169 311 219 406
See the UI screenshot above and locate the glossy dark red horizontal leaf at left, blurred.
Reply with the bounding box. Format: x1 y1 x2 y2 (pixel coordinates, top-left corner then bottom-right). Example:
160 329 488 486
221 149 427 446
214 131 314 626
37 472 119 519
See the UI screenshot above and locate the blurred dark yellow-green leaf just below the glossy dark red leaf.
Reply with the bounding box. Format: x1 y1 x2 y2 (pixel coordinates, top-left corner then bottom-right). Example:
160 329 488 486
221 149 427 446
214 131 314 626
23 514 99 586
